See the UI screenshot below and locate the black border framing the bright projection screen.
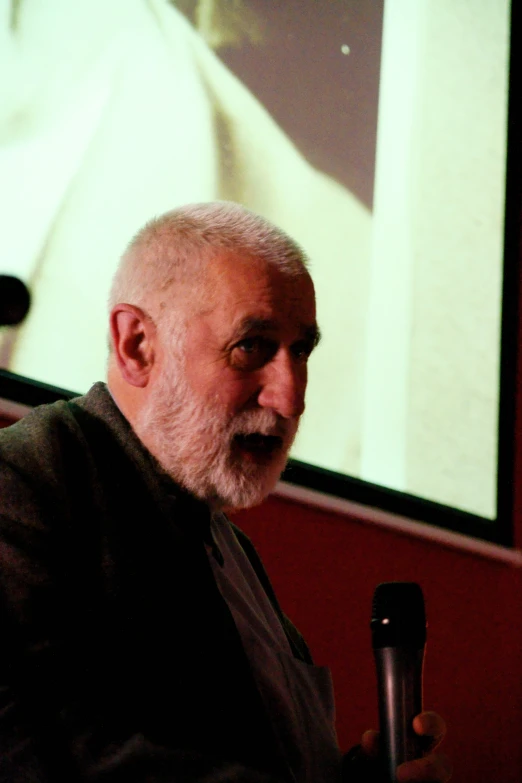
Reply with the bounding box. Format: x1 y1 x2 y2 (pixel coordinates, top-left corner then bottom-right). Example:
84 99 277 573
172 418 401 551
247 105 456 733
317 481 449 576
0 0 522 547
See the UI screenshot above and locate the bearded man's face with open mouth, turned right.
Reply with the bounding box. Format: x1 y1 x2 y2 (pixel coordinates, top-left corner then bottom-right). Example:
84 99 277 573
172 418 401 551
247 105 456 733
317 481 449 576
138 254 317 508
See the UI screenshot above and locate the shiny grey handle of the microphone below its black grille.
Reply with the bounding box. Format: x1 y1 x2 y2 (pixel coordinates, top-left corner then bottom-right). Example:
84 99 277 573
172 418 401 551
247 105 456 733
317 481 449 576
373 647 424 783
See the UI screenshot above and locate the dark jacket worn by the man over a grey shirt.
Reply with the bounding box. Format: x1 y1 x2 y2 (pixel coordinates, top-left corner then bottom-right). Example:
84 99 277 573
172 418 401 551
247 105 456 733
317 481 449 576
0 384 311 783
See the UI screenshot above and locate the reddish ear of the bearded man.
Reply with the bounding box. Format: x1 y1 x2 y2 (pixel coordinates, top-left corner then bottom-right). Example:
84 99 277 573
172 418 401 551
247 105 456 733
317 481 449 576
110 304 156 387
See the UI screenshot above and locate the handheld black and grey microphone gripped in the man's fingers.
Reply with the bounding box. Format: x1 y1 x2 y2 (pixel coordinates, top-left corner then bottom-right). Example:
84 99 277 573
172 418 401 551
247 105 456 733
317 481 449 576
371 582 426 783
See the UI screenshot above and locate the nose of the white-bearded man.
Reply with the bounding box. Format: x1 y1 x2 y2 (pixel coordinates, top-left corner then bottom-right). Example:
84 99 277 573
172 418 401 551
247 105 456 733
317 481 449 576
257 351 307 419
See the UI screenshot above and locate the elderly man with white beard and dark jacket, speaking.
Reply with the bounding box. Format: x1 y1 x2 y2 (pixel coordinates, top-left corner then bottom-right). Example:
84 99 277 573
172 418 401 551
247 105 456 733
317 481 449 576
0 202 448 783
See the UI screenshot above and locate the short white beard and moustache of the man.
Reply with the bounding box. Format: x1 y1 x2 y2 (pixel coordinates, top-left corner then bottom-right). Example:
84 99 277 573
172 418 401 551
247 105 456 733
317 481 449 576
136 360 297 510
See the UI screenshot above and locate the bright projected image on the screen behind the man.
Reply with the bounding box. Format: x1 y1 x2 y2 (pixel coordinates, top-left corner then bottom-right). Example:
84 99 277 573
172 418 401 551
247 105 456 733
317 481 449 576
0 0 509 518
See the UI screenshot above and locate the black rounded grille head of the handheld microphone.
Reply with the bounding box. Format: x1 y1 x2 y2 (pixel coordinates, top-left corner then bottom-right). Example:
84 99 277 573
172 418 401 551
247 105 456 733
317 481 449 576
371 582 426 649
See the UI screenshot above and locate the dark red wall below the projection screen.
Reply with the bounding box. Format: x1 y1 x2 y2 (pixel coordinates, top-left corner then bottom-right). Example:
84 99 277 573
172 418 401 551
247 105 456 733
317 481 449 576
235 498 522 783
